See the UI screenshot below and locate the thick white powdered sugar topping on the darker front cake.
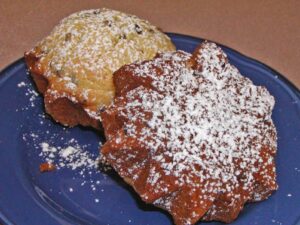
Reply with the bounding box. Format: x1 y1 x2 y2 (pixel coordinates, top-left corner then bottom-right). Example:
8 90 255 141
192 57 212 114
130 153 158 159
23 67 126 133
108 42 277 205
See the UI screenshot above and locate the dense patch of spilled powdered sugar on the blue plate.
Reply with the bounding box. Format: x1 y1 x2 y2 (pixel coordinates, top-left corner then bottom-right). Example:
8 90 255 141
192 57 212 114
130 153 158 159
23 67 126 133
22 130 103 185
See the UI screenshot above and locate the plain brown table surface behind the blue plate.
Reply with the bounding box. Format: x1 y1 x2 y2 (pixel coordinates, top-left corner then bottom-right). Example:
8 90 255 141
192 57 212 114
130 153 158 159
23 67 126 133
0 0 300 88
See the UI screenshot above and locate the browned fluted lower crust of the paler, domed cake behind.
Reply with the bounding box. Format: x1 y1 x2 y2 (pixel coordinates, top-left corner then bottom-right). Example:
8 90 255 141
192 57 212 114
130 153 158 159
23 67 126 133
24 51 101 130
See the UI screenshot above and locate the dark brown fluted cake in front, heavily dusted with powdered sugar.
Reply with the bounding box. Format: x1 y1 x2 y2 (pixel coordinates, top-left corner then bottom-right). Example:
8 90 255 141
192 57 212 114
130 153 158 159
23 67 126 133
101 42 277 225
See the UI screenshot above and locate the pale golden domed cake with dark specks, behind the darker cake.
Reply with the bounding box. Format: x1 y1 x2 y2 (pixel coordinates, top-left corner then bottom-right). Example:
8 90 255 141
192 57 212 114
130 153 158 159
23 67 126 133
25 9 175 129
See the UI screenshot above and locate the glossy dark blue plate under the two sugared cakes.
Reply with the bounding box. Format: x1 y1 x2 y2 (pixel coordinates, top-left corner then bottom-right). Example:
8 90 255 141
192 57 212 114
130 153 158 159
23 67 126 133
0 34 300 225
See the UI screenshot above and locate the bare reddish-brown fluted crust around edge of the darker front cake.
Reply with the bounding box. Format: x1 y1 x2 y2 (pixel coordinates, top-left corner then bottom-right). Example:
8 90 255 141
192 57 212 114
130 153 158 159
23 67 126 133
101 45 277 225
